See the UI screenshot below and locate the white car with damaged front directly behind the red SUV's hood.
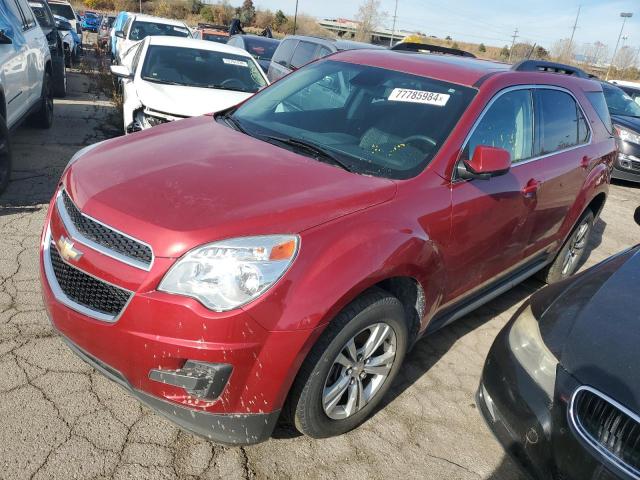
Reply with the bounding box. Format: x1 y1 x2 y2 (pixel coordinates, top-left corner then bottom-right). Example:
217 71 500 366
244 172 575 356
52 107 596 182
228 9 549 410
111 37 268 133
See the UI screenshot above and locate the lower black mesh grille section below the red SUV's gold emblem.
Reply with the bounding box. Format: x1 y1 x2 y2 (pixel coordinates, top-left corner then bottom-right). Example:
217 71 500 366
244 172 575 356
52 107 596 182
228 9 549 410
49 244 131 317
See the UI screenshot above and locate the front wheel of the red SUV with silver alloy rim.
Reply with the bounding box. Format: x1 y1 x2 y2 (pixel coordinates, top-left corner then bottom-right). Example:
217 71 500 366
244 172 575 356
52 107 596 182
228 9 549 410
285 289 408 438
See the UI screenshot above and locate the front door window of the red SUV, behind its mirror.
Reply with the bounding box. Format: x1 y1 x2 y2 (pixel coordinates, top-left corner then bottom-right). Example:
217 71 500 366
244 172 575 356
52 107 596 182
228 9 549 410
463 90 533 163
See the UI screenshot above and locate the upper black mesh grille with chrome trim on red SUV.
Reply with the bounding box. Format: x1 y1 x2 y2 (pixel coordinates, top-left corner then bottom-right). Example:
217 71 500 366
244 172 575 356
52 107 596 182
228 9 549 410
61 190 153 267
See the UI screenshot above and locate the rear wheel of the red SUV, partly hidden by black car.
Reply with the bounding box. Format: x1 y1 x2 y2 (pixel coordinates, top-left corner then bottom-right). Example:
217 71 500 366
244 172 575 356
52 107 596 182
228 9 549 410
538 210 594 283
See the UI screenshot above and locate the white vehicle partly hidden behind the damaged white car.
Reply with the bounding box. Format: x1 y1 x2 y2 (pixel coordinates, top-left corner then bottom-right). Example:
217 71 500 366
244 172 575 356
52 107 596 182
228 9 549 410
114 13 191 63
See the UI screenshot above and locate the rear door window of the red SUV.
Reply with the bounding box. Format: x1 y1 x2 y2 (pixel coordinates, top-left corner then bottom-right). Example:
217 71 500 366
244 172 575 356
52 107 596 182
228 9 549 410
537 89 588 155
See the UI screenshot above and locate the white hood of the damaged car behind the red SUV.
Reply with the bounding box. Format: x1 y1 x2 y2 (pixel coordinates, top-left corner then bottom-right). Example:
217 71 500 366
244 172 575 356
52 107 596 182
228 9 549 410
136 80 253 117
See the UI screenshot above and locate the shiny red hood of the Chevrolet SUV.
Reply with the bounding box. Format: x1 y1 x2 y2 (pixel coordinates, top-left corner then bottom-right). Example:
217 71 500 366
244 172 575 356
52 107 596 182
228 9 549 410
63 116 396 257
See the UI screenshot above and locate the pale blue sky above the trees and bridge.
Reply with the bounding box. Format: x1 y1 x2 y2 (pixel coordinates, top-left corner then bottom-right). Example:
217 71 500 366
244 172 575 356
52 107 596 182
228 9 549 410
231 0 640 51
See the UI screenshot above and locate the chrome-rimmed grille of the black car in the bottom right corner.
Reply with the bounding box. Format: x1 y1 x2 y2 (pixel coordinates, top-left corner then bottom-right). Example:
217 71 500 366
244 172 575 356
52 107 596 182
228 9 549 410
570 387 640 478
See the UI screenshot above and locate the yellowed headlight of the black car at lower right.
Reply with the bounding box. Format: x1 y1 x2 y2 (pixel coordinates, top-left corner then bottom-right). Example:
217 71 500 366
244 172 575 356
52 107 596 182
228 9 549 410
509 305 558 398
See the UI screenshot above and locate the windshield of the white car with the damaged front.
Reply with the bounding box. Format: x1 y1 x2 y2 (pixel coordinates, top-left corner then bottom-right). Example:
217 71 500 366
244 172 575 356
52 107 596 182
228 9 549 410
140 45 266 93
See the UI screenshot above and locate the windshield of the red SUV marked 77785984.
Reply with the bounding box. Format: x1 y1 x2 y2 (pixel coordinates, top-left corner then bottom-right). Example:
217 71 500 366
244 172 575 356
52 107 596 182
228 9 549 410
233 61 475 179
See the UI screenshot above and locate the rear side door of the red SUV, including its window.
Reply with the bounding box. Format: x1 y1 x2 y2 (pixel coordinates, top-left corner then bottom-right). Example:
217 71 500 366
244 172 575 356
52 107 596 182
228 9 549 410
525 87 596 256
